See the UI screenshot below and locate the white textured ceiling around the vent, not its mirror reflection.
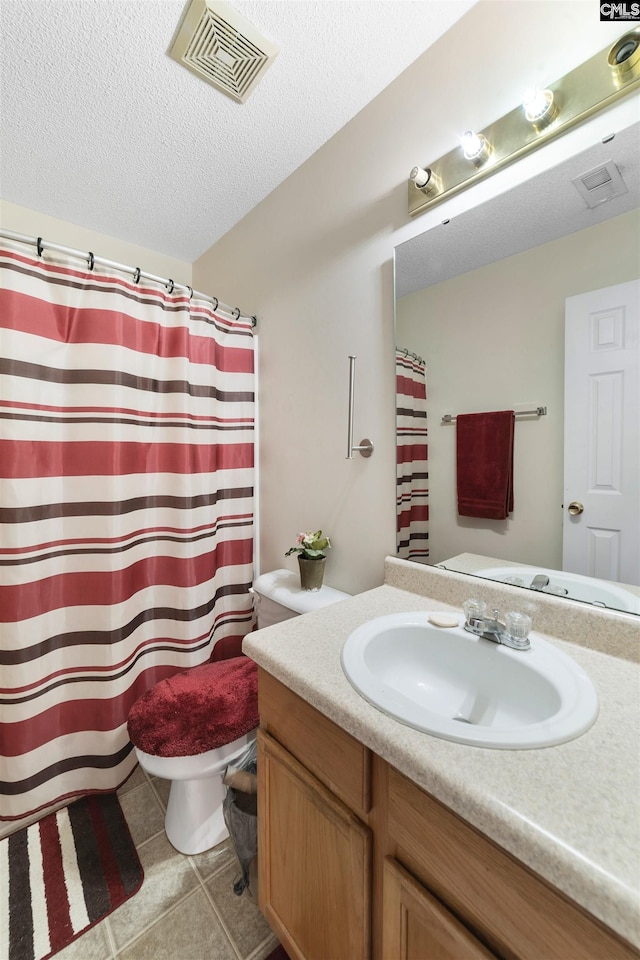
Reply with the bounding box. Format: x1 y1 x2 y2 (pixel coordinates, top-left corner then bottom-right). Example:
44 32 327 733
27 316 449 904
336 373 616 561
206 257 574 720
0 0 475 262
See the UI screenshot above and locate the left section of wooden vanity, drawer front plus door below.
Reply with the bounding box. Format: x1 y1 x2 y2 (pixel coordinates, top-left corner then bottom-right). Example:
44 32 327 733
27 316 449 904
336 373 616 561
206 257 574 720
258 671 372 960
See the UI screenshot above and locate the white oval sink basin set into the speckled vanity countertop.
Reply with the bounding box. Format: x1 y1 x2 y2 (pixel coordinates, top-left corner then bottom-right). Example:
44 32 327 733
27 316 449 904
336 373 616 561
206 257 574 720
342 613 598 750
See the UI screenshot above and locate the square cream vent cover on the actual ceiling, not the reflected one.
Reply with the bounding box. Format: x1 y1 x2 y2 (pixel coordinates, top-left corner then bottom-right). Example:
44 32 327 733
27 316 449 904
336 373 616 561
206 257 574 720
169 0 278 103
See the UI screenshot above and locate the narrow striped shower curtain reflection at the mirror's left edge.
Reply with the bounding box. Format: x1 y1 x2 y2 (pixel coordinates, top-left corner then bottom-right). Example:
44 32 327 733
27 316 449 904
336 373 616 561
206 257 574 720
396 350 429 560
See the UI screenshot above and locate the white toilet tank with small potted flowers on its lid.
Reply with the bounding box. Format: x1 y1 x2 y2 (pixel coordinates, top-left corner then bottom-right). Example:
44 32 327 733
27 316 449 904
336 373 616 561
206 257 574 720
253 570 350 630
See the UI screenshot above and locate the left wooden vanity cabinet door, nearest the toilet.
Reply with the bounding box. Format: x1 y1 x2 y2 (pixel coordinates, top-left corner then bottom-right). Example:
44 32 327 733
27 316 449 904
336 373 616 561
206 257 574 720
258 730 371 960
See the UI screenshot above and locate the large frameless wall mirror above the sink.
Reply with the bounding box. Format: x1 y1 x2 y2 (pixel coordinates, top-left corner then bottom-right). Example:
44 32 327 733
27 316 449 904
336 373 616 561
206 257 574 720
395 124 640 613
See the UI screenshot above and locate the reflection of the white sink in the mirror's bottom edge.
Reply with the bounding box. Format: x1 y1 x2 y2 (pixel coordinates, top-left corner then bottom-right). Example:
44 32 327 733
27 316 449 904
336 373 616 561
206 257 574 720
474 566 640 613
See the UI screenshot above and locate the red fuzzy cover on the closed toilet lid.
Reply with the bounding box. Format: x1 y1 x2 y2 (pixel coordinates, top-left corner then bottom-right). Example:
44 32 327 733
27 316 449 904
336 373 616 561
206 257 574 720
128 656 259 757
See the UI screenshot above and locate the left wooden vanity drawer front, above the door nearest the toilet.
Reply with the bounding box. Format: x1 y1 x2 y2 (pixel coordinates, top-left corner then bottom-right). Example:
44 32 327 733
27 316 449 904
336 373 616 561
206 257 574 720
258 669 371 816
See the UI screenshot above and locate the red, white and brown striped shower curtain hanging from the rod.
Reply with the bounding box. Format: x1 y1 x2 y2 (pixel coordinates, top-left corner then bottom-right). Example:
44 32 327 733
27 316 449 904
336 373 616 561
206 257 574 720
0 249 254 819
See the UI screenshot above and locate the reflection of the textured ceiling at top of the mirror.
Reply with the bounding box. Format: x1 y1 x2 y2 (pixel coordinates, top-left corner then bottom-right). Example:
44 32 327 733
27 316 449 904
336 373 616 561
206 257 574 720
395 123 640 297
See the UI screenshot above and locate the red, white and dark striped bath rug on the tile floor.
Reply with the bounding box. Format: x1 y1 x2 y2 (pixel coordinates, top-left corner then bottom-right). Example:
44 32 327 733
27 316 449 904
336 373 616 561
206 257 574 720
0 793 143 960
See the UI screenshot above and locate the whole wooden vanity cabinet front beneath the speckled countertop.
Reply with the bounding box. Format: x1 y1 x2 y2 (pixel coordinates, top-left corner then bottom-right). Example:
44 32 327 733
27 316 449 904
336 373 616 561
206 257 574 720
258 670 640 960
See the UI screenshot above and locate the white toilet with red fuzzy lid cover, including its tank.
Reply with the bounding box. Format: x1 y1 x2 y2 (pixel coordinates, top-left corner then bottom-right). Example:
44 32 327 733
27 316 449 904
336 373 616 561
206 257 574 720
128 569 348 854
